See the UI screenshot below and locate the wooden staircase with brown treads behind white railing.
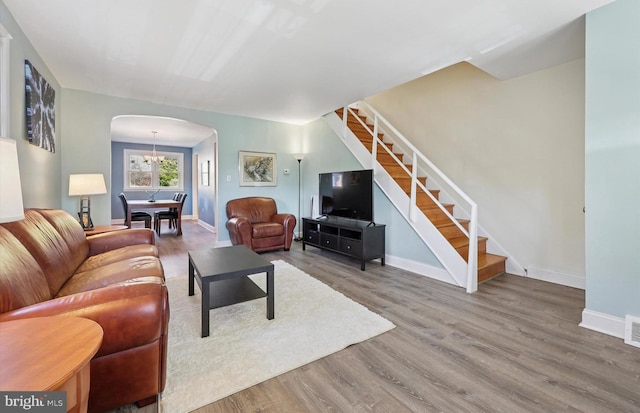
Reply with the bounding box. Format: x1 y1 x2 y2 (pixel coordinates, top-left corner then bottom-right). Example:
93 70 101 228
335 104 507 292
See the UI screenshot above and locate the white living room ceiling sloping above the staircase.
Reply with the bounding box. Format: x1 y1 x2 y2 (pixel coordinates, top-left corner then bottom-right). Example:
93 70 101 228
2 0 612 146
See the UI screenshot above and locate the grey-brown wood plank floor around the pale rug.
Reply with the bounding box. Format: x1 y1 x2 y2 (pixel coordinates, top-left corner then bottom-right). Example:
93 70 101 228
149 222 640 413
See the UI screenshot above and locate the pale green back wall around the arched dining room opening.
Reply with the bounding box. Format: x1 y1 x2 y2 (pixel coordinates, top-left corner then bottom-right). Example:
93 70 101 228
62 89 301 233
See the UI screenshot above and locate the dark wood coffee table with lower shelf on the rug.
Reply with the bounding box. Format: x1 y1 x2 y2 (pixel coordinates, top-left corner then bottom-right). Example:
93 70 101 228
189 245 274 337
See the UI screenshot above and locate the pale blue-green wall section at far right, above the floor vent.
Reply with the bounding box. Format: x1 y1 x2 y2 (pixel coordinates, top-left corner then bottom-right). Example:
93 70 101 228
585 0 640 317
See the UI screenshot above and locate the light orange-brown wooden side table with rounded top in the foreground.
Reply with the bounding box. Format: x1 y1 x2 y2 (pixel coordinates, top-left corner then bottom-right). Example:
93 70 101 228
0 317 103 413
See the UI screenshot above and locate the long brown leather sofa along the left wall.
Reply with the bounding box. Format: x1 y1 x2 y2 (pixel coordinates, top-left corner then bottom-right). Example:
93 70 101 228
0 209 169 412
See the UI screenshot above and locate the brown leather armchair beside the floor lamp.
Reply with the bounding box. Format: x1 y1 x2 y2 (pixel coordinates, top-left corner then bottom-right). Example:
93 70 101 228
227 197 296 252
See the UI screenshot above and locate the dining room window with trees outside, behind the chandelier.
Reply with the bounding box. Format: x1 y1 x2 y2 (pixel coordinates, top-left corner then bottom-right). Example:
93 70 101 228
123 149 184 191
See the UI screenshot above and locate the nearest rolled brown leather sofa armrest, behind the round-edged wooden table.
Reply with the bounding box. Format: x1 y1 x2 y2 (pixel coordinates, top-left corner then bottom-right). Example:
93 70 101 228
0 277 169 357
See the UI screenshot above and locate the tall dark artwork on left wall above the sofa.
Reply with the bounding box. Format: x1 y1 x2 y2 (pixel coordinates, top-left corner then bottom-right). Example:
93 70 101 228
24 60 56 152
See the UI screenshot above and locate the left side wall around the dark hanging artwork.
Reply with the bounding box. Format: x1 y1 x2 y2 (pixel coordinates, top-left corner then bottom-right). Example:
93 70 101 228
0 2 64 208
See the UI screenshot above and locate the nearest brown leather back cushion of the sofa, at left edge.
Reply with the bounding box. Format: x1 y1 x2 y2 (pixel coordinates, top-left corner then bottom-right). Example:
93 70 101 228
0 226 51 313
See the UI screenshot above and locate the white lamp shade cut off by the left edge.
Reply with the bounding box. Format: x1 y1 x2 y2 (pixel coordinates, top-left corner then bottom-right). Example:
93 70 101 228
0 138 24 222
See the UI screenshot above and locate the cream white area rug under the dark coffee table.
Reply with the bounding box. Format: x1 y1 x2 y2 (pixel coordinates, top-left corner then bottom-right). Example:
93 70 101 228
152 260 395 413
